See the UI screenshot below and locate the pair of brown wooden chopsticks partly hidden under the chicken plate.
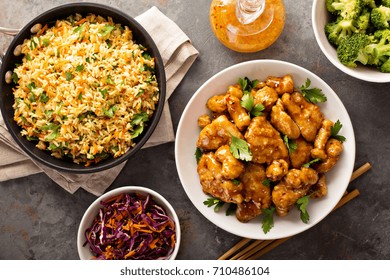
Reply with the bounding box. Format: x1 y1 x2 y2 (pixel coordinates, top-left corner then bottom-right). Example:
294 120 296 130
218 162 371 260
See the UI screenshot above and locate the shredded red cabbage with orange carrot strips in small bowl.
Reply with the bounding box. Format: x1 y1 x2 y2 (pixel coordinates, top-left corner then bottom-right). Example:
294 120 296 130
84 193 176 260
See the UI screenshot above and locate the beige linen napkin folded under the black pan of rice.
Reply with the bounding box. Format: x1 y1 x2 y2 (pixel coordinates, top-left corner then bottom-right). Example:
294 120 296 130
0 7 198 196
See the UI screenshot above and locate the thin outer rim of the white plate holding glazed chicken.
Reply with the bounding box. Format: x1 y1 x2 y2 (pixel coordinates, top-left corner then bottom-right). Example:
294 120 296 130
175 59 356 240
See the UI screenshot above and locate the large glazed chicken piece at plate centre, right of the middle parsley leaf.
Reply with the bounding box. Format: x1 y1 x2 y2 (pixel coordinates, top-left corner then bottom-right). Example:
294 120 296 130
245 116 288 164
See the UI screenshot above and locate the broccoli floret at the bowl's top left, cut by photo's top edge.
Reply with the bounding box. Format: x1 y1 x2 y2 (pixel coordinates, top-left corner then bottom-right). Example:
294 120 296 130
326 0 363 19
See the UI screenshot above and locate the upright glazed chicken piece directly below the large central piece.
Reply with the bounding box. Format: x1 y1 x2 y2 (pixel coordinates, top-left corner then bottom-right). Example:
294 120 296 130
240 163 271 208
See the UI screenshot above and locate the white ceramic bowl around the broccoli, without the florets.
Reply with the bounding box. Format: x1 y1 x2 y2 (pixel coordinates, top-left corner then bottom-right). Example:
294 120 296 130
312 0 390 83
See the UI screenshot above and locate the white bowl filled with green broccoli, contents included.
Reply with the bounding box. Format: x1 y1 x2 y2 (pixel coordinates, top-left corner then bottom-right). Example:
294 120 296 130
312 0 390 83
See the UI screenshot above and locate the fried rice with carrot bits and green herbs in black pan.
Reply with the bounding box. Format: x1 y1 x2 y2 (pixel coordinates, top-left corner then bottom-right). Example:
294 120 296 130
13 14 159 165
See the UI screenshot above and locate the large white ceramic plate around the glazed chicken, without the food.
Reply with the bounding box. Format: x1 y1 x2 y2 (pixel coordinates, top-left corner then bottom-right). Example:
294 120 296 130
175 60 355 239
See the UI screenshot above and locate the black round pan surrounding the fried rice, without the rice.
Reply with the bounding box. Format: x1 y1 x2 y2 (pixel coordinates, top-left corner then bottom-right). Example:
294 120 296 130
0 3 166 173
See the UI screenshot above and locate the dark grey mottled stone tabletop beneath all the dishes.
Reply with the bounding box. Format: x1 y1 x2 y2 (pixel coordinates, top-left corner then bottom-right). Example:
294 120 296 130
0 0 390 260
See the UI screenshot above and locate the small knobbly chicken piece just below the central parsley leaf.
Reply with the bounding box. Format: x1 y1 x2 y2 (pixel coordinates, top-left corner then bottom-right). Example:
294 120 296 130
215 145 245 179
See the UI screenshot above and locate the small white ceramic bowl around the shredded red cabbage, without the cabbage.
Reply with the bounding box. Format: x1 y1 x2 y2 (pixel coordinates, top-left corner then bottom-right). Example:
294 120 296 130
77 186 181 260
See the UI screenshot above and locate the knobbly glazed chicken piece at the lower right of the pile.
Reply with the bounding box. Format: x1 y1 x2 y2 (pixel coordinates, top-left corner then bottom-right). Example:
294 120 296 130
272 167 318 217
